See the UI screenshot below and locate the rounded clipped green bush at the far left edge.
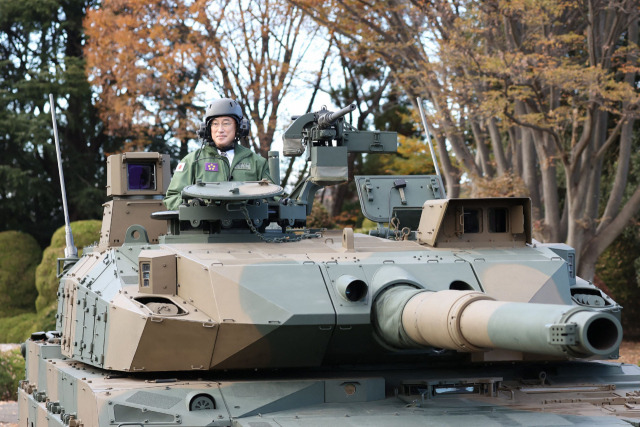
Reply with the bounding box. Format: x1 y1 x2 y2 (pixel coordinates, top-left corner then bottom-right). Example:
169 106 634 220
0 231 42 317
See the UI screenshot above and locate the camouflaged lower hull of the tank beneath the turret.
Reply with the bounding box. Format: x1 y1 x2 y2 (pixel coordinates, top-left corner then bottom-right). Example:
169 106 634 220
18 340 640 427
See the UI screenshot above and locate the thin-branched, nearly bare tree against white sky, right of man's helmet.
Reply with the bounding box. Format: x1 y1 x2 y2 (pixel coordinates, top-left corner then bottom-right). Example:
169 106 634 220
206 0 318 157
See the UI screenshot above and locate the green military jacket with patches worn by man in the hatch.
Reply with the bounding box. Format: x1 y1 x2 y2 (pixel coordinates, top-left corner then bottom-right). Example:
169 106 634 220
164 144 273 210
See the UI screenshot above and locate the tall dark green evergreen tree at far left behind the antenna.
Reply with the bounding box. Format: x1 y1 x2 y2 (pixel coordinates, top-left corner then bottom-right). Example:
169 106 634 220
0 0 117 247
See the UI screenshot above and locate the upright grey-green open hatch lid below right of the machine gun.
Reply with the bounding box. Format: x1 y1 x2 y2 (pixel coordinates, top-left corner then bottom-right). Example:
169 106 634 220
355 175 442 230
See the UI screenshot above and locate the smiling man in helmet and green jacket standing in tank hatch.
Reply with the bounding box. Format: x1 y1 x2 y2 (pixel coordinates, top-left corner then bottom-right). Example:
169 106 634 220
164 98 273 210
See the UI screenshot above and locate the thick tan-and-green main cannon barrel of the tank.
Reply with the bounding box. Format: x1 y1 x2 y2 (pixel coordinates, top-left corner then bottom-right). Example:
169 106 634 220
374 286 622 358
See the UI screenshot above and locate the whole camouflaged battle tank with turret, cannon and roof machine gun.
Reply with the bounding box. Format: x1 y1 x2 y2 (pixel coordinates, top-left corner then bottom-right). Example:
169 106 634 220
19 106 640 427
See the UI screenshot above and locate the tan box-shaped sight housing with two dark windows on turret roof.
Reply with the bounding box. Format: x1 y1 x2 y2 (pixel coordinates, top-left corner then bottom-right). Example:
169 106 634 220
417 197 531 248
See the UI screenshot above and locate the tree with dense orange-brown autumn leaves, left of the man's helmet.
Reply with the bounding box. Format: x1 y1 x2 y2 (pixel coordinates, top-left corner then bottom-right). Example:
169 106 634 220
84 0 210 157
